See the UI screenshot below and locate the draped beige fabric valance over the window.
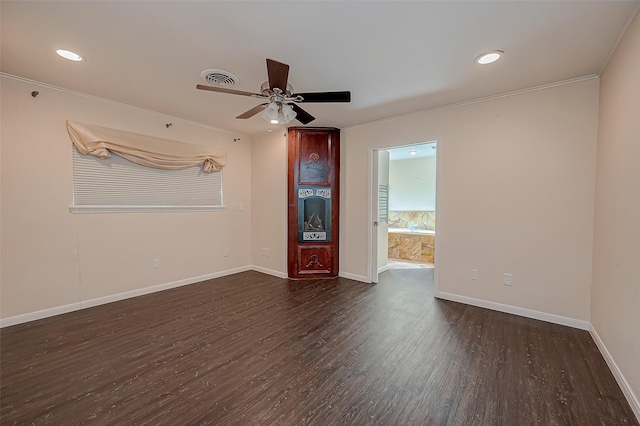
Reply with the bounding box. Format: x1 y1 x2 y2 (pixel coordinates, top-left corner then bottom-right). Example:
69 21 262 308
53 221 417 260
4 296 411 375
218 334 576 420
67 120 227 172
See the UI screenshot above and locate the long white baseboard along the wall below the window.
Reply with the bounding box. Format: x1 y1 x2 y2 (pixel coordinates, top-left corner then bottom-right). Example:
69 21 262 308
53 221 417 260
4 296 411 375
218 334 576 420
0 266 252 328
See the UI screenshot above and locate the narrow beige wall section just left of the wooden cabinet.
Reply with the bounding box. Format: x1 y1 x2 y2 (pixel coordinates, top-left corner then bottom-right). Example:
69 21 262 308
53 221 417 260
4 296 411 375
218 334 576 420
251 129 287 277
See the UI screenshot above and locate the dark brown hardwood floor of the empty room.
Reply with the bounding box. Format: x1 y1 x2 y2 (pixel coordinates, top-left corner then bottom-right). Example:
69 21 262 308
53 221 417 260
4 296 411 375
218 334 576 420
0 269 638 426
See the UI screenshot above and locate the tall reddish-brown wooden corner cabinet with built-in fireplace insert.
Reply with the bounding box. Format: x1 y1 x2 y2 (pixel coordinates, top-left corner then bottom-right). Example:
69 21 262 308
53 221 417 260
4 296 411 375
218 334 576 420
287 127 340 278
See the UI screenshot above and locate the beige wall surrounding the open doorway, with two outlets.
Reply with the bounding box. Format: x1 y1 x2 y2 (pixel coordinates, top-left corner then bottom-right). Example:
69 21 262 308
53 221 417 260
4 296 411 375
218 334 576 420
340 79 599 321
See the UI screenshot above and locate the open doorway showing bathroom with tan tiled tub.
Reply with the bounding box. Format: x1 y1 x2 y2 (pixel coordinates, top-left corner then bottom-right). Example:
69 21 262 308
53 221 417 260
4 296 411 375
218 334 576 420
371 141 437 282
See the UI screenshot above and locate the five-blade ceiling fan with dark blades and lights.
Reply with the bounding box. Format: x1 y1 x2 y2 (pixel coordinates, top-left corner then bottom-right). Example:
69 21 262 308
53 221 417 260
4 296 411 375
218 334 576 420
196 59 351 124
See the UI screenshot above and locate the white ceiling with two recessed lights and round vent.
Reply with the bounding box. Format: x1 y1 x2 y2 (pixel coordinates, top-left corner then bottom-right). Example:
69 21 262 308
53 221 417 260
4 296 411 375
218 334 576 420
0 0 640 135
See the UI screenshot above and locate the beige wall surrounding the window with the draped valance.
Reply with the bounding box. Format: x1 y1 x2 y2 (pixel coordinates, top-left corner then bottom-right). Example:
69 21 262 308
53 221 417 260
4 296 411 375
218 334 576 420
0 76 251 318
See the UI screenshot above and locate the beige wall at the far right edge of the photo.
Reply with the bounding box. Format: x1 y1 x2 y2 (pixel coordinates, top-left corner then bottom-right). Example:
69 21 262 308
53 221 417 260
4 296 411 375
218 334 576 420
591 11 640 417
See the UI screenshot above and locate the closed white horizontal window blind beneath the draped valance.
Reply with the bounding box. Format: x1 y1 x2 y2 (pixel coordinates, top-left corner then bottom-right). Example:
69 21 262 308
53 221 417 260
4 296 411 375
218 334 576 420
70 145 224 213
